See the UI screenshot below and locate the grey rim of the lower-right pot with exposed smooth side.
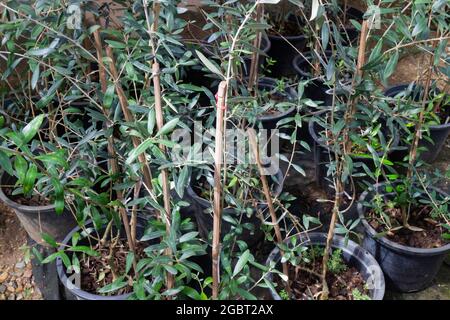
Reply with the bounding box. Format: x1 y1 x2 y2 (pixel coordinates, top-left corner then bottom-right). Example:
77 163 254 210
357 182 450 256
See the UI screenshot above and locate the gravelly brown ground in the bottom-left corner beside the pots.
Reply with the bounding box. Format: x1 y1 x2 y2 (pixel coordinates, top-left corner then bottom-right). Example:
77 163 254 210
0 203 42 300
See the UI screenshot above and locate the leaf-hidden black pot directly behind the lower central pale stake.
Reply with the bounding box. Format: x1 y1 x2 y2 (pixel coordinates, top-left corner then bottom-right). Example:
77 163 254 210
186 171 283 248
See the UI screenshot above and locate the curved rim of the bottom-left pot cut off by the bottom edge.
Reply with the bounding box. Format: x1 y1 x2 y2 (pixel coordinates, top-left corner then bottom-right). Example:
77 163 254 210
56 215 146 300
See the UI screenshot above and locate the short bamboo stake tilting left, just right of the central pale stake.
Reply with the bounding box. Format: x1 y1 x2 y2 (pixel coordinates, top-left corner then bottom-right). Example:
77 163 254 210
247 128 291 294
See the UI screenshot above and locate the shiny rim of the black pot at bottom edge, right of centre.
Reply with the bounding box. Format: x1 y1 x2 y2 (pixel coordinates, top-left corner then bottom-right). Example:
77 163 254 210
265 232 386 300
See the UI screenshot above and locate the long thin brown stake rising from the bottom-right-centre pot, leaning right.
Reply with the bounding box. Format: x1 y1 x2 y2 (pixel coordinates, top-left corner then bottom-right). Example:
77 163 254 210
320 20 369 300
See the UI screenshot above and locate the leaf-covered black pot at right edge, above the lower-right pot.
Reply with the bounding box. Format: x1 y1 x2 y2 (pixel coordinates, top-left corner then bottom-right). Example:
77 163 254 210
384 84 450 163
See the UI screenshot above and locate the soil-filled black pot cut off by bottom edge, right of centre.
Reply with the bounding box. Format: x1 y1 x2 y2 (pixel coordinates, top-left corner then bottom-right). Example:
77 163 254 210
266 233 384 300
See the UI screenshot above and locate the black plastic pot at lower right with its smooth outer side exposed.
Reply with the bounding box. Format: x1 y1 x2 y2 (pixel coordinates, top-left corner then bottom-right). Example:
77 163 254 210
358 184 450 292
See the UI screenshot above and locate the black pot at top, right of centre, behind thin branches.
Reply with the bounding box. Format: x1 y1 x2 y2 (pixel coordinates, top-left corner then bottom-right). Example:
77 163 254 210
268 15 306 78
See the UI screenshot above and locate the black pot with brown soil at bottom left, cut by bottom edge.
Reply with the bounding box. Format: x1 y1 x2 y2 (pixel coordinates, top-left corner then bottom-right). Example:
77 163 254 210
56 217 147 300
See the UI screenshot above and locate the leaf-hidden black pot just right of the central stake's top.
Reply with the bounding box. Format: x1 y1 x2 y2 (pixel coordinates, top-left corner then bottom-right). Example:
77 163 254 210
256 78 296 130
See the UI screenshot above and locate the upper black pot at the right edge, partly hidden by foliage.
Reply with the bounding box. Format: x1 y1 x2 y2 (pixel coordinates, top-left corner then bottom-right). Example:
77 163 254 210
384 84 450 163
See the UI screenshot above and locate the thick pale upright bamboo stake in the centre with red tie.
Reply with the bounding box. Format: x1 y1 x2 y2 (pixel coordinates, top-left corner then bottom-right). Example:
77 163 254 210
212 81 227 299
